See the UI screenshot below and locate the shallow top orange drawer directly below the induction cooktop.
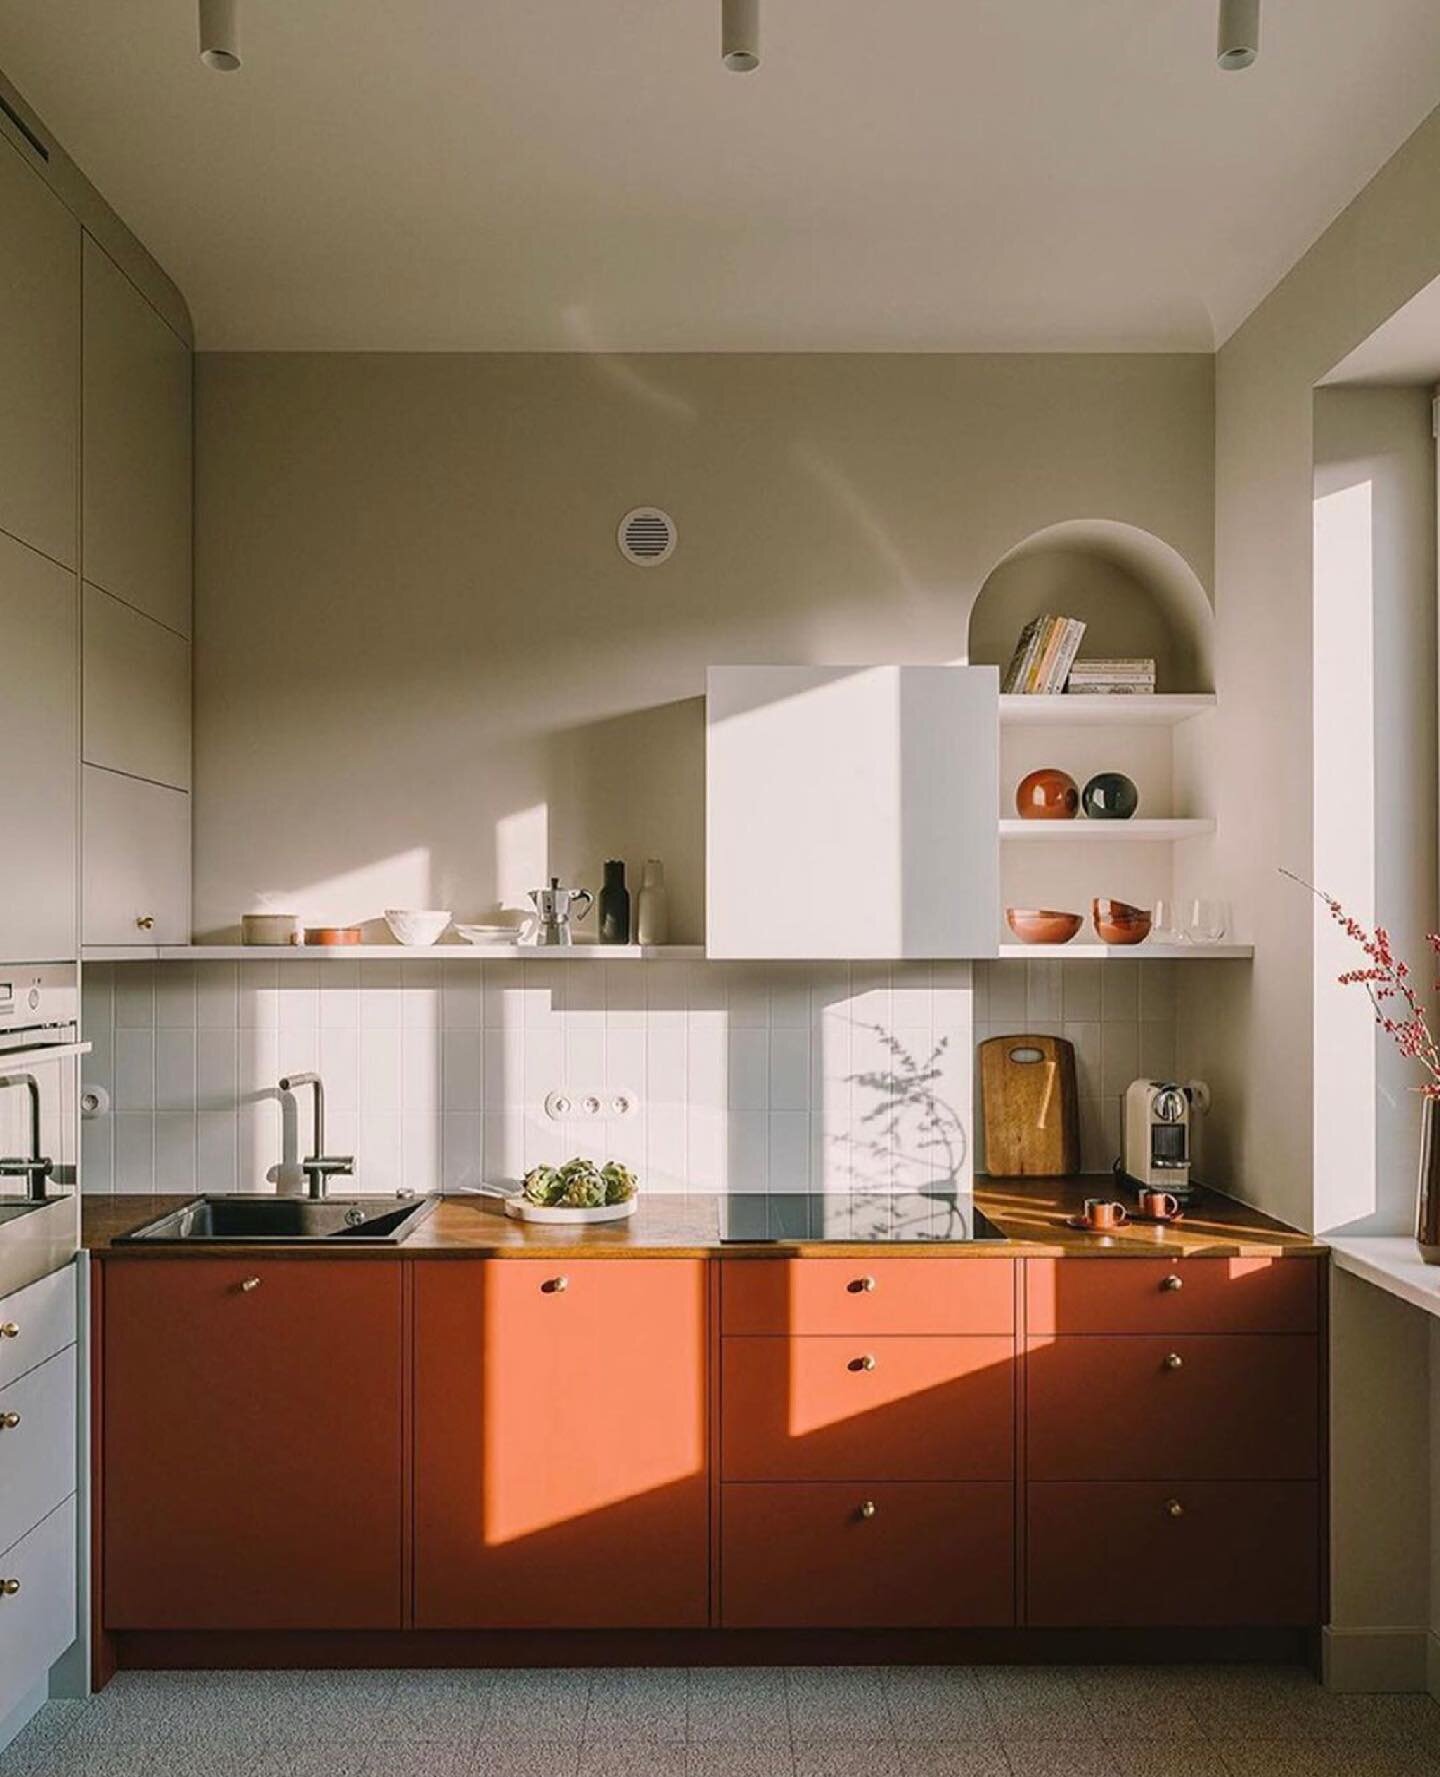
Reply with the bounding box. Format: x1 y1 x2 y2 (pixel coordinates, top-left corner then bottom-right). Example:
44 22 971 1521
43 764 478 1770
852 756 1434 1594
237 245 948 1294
720 1256 1015 1335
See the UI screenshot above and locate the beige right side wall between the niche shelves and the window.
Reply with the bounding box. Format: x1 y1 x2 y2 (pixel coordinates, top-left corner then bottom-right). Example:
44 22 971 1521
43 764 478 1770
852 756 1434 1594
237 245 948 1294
1188 100 1440 1226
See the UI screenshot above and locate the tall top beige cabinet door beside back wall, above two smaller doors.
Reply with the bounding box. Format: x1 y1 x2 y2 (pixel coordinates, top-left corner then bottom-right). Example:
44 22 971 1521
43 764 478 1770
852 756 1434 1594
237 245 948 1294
82 235 192 636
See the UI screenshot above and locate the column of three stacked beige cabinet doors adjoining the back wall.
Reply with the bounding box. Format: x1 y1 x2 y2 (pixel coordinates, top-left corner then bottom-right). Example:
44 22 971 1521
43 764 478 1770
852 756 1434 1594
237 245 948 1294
80 236 192 944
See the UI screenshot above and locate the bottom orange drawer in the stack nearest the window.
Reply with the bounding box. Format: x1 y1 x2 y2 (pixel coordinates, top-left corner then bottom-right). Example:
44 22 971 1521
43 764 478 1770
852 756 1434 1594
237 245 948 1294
1026 1480 1319 1628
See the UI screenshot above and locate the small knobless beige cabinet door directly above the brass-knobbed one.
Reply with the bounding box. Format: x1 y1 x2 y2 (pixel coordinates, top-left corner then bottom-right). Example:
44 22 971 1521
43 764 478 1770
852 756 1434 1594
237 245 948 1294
82 586 190 789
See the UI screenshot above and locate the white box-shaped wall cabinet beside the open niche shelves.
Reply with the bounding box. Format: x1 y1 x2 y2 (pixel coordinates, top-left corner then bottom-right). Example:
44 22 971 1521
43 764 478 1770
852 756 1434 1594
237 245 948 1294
706 666 999 960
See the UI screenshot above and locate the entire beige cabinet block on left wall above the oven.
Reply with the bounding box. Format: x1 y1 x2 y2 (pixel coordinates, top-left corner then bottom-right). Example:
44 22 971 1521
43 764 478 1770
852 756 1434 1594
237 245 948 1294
0 93 192 961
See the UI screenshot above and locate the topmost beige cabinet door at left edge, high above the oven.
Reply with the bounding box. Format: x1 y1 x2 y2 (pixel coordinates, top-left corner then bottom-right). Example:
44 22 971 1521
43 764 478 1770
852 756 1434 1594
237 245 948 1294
0 139 80 567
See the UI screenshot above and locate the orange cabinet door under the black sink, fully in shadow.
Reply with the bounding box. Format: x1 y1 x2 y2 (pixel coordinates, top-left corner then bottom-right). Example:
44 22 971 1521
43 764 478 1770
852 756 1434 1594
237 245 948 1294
101 1258 404 1630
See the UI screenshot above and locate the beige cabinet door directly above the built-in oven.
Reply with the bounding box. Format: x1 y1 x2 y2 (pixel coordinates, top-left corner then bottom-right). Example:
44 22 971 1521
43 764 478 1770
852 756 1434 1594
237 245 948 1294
0 535 80 961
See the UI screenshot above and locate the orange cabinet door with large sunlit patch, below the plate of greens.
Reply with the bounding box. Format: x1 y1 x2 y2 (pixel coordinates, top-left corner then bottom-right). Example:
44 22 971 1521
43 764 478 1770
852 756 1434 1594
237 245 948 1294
414 1258 709 1630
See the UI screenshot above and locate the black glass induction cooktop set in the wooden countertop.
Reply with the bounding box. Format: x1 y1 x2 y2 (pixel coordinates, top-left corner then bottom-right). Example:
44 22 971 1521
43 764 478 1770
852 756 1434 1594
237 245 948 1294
720 1191 1004 1242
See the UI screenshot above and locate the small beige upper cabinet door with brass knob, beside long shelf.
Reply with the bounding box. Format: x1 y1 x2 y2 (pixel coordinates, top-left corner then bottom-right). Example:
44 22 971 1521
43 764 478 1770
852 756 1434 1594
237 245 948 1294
84 766 190 944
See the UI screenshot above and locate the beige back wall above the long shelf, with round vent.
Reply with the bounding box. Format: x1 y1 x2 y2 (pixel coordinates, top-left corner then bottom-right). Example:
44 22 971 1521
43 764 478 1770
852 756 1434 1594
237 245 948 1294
196 354 1214 940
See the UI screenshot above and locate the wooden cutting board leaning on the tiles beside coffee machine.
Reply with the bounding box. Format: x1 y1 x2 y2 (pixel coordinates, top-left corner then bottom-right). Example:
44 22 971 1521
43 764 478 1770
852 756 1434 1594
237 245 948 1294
980 1036 1079 1178
